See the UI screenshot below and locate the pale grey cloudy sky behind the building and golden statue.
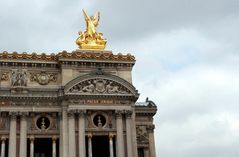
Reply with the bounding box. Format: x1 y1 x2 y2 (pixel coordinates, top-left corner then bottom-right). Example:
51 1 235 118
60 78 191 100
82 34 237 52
0 0 239 157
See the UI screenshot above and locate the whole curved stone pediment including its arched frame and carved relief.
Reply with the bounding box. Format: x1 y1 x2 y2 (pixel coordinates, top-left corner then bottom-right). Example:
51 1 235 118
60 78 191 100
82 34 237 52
64 74 138 97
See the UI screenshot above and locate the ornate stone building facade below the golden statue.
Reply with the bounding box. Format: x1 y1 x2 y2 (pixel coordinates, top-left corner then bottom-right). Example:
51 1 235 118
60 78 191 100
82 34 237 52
0 50 157 157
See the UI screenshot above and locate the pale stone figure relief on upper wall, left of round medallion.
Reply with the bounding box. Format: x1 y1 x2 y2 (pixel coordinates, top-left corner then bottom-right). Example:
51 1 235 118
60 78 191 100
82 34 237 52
11 69 27 86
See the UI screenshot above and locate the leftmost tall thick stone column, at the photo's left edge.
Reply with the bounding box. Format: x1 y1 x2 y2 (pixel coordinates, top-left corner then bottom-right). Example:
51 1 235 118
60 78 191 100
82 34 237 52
8 112 17 157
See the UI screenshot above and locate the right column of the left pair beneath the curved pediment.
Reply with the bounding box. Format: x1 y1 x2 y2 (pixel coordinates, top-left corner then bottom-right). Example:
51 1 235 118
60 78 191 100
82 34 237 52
78 110 86 157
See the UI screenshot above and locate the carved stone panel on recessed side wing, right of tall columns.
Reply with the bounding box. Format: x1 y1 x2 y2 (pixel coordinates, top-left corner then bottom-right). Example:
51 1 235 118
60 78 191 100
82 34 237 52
136 125 149 144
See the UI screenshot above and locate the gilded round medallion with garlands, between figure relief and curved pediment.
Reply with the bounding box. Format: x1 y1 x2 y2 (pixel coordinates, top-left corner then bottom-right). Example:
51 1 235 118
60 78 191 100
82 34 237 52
30 72 57 85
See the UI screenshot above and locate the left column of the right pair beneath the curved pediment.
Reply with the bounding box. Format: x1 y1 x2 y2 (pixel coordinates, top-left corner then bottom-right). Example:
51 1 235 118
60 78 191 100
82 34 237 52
115 111 125 157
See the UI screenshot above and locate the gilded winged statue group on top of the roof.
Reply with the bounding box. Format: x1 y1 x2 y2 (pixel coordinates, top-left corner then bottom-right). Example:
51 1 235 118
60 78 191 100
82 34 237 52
76 10 106 50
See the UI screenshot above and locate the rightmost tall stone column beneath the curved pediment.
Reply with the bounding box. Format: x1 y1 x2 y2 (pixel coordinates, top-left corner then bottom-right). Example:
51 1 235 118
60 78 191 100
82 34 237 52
125 110 133 157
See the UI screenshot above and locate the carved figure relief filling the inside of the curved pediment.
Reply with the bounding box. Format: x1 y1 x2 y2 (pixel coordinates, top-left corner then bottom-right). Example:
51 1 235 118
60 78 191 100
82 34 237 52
70 78 130 94
